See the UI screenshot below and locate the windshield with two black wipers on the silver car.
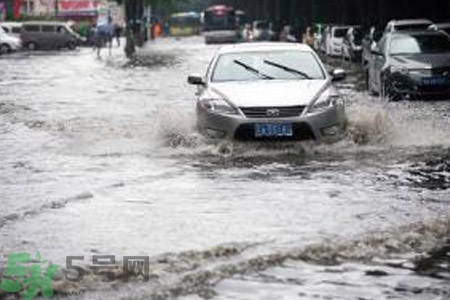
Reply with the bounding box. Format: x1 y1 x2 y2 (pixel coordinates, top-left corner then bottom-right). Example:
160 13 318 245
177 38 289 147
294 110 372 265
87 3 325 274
212 50 325 82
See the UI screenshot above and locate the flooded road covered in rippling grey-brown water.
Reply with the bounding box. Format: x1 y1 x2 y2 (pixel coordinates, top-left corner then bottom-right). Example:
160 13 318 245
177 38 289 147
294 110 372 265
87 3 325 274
0 38 450 300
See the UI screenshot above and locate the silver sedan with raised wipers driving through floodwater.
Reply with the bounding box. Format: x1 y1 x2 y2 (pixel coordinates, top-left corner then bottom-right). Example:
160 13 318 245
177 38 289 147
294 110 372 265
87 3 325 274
188 43 346 141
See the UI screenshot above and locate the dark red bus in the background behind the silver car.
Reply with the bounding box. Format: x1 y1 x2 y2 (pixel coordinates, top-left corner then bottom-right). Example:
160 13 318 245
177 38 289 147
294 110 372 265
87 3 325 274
203 5 238 44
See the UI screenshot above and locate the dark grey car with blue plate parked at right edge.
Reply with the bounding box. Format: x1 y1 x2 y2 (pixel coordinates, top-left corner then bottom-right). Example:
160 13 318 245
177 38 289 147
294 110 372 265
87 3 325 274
368 30 450 101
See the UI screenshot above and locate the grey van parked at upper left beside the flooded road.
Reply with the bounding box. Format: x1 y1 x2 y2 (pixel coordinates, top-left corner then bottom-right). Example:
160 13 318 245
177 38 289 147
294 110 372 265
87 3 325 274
21 21 82 50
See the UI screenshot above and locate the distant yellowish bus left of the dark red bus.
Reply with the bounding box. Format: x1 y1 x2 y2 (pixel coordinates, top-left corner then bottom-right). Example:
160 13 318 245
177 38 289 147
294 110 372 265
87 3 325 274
169 12 201 36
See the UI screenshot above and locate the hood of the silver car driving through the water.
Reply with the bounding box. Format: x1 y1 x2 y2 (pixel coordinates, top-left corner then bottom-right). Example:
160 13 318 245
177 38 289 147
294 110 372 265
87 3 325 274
210 79 330 107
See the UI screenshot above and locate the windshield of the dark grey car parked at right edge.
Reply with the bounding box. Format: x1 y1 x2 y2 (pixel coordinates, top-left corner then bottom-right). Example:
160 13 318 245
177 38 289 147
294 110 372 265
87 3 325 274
390 34 450 55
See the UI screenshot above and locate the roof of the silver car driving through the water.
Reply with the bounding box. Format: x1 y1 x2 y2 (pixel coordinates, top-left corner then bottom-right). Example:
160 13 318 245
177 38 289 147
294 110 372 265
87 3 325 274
218 42 313 54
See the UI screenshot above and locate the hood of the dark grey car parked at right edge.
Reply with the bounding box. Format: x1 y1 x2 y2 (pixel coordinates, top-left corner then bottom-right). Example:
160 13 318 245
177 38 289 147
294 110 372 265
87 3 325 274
392 53 450 69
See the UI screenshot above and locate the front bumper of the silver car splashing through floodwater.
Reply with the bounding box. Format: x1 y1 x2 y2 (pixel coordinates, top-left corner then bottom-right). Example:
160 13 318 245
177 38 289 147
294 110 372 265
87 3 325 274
197 104 346 141
